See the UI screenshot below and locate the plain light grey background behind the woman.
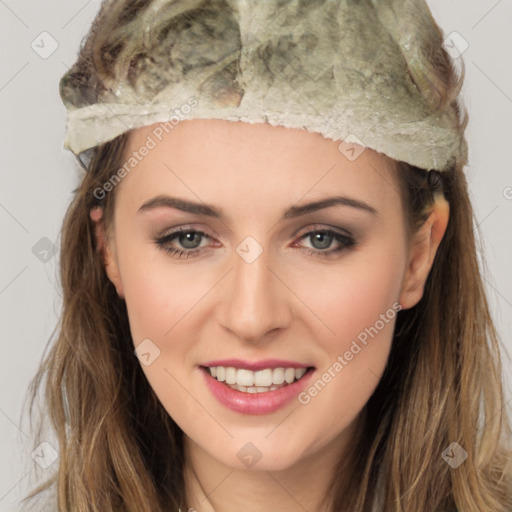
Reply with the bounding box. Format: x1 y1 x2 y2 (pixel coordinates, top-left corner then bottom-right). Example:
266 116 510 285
0 0 512 511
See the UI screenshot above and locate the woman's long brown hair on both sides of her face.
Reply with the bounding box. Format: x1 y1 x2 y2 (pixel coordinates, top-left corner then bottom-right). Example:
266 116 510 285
22 2 512 512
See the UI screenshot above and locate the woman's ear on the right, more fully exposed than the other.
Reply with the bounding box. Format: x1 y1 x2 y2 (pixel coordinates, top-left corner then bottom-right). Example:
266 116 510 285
399 196 450 309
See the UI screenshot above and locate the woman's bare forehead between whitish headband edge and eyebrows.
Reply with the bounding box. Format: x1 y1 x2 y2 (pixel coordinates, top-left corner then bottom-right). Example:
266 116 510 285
121 119 399 215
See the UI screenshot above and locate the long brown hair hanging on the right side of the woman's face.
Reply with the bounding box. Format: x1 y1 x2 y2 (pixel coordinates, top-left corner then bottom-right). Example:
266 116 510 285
322 158 512 512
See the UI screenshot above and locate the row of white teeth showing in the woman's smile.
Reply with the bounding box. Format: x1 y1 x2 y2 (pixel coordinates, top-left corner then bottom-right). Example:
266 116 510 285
201 366 314 393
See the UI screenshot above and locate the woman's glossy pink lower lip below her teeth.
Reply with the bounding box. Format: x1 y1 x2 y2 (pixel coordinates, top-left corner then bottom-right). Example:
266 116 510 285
200 367 314 414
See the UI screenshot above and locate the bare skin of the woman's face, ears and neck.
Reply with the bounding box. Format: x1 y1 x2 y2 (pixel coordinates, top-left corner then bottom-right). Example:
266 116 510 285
92 120 449 512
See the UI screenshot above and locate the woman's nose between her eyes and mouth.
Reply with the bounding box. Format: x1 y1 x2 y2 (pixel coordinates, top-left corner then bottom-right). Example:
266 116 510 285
218 243 292 344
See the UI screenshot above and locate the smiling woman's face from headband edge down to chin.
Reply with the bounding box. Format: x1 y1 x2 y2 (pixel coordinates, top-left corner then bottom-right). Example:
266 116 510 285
101 120 436 470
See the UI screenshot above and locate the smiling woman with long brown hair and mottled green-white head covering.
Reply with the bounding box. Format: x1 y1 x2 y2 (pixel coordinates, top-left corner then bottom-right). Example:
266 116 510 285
24 0 512 512
